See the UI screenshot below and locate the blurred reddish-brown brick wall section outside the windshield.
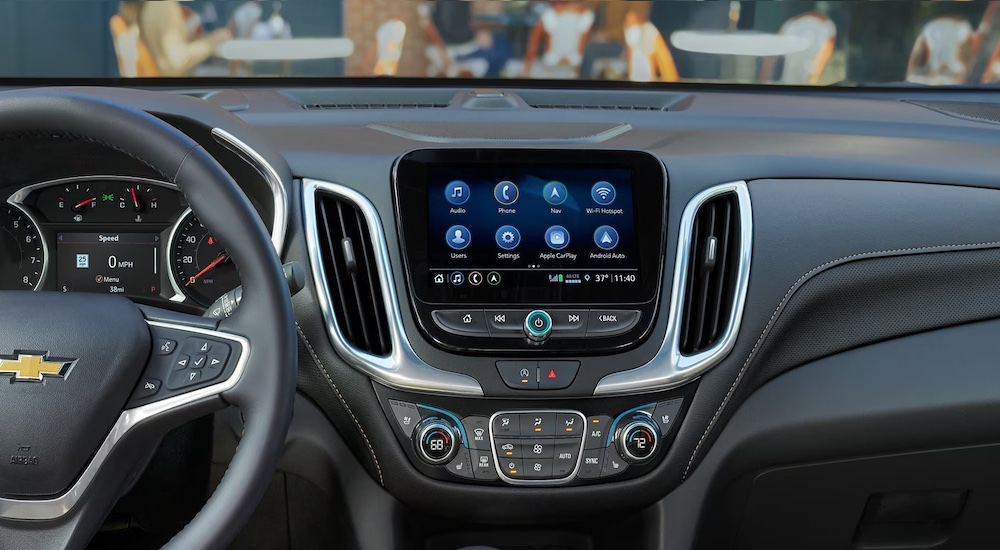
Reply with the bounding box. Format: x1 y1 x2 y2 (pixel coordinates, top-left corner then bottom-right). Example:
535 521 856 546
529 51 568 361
344 0 427 76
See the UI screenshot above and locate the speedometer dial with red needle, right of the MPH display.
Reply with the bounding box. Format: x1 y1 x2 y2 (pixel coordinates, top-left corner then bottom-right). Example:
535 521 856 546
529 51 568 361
171 213 240 306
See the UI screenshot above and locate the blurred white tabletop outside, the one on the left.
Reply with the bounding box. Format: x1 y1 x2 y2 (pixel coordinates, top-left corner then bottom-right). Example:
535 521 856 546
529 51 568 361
216 38 354 61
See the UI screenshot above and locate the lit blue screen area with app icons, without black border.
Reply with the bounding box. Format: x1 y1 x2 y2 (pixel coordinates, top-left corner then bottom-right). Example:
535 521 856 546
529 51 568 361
427 164 636 293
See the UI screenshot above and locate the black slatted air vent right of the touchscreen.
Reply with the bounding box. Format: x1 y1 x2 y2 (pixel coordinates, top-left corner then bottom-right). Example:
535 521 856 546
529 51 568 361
680 192 741 355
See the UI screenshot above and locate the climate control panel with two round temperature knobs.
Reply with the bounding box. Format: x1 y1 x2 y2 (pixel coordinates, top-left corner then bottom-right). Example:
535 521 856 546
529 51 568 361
385 397 685 486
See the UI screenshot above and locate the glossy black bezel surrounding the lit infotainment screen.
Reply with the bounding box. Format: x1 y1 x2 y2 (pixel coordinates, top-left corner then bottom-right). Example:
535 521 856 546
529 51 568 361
393 149 667 305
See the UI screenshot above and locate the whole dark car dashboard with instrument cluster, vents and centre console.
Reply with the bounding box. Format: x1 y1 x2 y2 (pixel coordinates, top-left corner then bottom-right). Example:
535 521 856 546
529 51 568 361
0 85 1000 549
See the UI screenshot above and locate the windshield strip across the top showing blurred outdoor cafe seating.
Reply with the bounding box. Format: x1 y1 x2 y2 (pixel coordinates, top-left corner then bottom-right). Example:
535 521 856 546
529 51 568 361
7 0 1000 86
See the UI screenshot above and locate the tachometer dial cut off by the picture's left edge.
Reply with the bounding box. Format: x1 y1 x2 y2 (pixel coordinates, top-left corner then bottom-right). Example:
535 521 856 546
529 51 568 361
0 205 45 290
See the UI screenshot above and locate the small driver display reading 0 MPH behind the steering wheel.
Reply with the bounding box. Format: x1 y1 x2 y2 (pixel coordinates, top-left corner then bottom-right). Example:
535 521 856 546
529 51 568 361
56 233 162 296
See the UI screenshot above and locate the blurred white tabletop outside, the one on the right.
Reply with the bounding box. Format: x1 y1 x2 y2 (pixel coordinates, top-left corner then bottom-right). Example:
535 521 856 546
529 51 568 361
670 31 810 57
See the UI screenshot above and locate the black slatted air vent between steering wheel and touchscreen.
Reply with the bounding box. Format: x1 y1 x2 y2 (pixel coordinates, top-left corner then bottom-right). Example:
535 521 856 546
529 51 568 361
316 193 391 356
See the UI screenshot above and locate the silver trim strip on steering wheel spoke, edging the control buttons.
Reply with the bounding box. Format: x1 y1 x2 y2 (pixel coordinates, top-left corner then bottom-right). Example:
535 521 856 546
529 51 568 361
0 321 250 520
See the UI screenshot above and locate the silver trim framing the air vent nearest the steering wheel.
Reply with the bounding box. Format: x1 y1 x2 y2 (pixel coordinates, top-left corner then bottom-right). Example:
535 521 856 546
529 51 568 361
302 179 483 396
